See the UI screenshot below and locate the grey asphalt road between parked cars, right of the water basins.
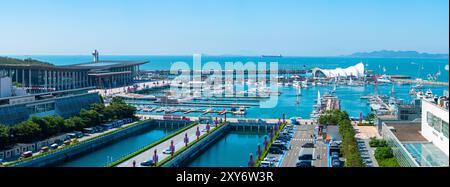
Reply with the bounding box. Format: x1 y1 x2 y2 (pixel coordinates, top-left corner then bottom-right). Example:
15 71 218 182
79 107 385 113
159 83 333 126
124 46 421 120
281 125 315 167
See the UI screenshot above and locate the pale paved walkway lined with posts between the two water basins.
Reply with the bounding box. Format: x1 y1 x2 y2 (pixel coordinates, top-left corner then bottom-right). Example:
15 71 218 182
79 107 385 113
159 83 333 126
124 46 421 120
117 124 215 167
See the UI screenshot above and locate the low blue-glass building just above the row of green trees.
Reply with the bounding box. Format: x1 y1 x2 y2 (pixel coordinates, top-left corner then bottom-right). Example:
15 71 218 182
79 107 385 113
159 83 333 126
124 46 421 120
0 87 101 125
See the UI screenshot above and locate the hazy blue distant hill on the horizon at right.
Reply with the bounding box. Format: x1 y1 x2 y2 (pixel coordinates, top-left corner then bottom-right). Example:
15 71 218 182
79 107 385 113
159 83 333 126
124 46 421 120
348 50 448 58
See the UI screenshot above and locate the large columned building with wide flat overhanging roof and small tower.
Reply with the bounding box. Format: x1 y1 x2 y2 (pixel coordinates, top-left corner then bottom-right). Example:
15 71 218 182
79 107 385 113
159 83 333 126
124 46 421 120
0 52 148 93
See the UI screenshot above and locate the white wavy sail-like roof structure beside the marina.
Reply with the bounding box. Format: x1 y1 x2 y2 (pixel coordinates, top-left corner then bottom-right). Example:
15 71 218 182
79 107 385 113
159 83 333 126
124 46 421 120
312 62 364 78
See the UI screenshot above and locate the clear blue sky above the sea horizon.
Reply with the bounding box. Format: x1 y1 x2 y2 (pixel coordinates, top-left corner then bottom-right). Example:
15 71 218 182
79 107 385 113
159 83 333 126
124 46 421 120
0 0 449 56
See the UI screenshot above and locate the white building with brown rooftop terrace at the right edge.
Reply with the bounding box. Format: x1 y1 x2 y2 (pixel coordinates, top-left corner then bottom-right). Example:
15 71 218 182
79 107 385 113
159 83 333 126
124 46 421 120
381 93 449 167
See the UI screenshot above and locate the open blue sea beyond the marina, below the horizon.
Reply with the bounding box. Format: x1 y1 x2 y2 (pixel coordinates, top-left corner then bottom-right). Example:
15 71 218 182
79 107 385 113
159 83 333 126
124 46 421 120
8 55 449 82
